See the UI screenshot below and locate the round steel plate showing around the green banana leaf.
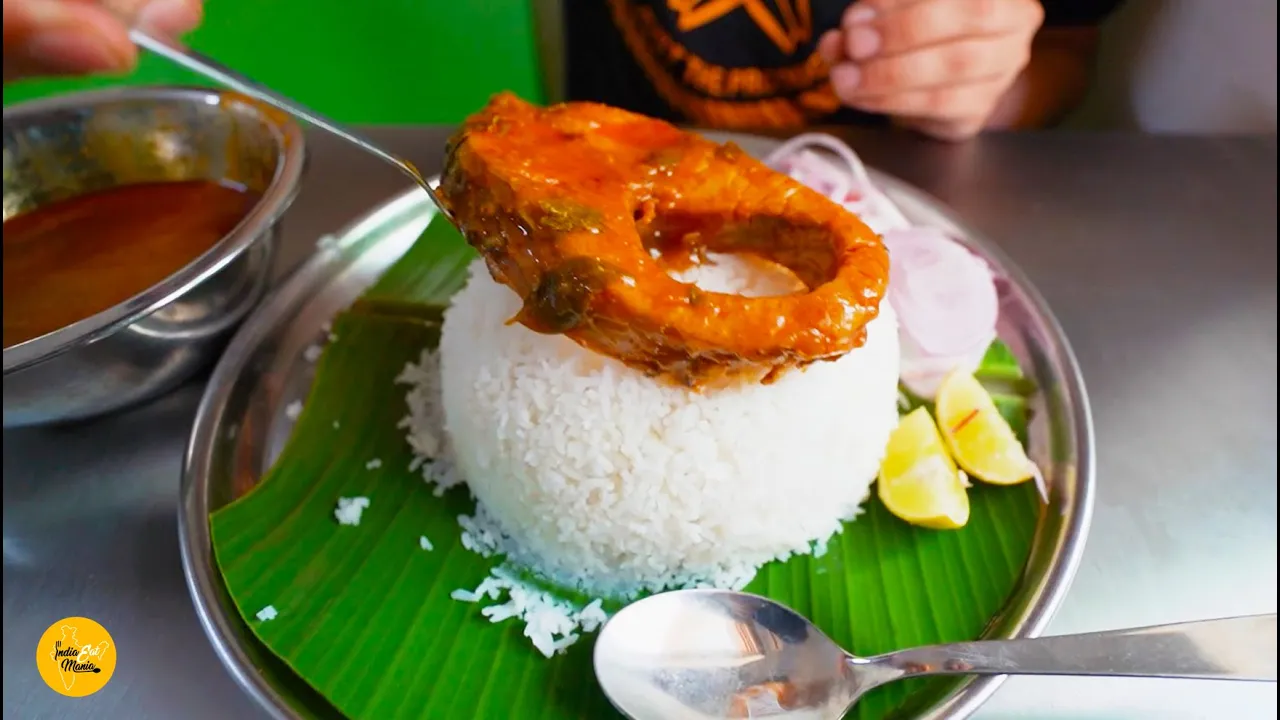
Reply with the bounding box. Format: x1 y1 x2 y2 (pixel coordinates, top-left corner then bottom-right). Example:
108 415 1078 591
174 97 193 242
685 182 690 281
178 133 1094 720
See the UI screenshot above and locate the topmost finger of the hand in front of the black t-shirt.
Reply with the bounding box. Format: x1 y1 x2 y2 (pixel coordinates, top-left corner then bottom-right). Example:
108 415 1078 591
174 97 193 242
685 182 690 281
841 0 1044 60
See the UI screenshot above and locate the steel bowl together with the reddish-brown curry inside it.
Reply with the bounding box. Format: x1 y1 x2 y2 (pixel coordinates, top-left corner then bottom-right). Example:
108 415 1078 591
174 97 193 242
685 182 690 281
4 87 306 428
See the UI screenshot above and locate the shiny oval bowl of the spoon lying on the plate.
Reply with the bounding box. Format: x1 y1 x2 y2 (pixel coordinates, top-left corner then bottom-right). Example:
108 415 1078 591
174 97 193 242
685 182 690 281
595 589 861 720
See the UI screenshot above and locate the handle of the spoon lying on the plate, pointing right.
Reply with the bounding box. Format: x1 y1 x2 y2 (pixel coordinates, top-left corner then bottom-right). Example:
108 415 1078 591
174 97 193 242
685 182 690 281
851 614 1276 684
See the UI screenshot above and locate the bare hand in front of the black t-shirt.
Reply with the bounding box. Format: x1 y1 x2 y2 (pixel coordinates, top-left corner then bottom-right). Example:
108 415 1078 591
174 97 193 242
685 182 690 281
818 0 1044 140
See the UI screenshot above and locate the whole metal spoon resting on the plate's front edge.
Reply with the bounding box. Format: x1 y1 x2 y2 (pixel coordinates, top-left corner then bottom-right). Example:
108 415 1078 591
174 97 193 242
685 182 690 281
595 589 1276 720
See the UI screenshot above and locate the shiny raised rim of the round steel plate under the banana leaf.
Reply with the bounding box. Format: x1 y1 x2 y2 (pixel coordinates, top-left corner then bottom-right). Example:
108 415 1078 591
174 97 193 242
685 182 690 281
178 158 1096 720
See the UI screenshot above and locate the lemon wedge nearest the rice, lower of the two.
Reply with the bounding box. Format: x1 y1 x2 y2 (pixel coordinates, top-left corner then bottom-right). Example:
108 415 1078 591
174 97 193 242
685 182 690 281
876 407 969 530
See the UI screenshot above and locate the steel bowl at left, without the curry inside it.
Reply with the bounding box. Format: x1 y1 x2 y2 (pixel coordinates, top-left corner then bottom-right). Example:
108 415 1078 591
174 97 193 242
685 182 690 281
4 87 306 428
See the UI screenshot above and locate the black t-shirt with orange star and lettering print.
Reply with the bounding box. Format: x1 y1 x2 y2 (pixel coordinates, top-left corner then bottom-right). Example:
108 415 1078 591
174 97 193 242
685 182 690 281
564 0 1120 129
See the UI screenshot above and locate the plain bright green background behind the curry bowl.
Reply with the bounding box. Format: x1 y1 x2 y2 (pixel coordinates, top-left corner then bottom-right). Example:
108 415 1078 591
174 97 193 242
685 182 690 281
4 0 545 124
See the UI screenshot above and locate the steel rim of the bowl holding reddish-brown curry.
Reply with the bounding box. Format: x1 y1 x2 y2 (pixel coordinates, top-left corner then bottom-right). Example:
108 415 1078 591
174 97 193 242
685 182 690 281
4 86 306 375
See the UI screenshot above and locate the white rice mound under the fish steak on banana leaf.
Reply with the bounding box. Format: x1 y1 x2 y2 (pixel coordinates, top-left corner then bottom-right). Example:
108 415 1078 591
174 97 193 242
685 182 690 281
439 256 899 597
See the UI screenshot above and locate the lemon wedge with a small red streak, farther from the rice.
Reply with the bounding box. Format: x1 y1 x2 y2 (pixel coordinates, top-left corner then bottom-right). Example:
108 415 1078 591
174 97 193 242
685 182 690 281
934 370 1036 486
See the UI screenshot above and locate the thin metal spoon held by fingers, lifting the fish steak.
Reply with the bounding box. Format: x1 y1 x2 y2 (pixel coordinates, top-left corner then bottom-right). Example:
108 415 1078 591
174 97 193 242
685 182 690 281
129 28 453 222
